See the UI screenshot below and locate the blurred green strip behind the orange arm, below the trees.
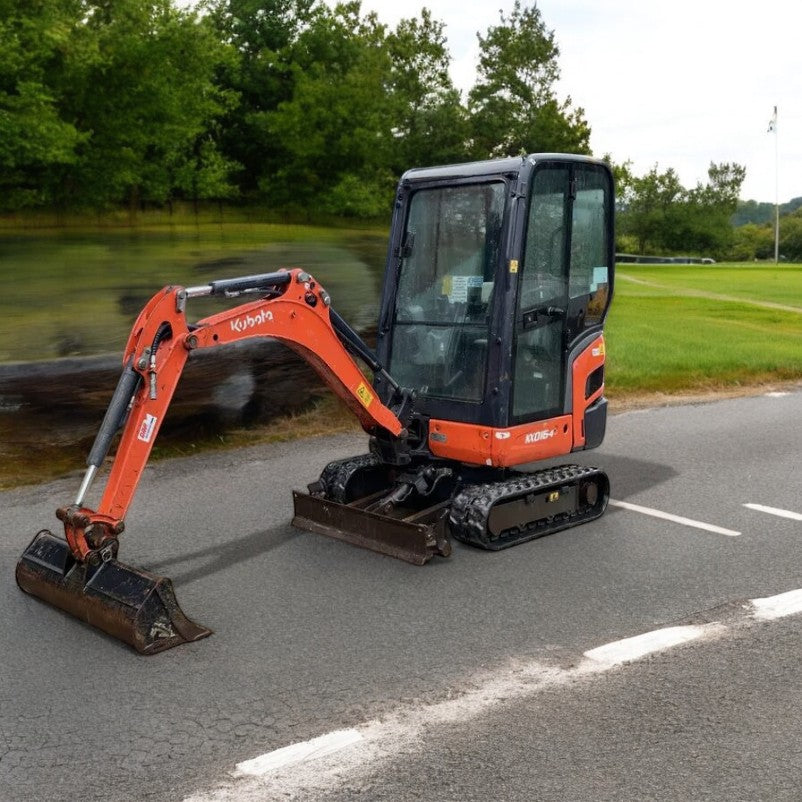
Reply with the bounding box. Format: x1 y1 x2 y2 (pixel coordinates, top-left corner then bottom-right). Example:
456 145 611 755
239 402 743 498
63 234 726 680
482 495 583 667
0 223 386 362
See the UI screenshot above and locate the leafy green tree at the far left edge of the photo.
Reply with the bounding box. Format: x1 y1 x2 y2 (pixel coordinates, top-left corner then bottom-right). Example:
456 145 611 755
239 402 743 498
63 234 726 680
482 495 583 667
0 0 85 209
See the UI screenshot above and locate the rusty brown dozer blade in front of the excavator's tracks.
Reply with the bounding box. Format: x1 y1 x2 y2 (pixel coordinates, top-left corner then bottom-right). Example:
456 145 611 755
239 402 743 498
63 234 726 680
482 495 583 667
292 490 451 565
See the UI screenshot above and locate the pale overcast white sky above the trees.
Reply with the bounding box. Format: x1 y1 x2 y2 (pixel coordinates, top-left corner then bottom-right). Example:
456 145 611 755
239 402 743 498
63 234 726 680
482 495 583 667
344 0 802 203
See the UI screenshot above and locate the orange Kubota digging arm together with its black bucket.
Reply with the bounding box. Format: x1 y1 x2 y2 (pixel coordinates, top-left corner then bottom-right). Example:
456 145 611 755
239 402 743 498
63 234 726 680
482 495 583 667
16 269 412 654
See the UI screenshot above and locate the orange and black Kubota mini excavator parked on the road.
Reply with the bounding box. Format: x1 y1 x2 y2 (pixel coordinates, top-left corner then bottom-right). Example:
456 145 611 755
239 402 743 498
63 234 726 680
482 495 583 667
16 154 614 654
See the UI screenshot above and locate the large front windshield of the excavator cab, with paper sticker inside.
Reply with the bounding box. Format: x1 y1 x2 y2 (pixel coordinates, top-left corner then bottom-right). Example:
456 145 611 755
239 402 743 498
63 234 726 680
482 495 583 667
390 181 505 402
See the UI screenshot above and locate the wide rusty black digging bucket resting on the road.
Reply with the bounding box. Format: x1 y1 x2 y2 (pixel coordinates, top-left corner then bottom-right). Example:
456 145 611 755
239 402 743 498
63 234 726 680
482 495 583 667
16 530 211 654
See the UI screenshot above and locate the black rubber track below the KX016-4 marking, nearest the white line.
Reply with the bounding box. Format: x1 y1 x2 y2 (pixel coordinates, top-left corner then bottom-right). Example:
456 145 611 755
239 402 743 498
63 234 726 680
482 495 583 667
449 465 607 550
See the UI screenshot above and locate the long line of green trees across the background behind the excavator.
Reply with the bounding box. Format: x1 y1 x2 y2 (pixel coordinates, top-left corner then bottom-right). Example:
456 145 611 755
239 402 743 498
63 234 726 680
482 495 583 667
0 0 764 255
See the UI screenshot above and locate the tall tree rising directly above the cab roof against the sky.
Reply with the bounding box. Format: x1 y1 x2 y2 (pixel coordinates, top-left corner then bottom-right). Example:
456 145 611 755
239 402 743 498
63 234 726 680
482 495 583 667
468 0 590 158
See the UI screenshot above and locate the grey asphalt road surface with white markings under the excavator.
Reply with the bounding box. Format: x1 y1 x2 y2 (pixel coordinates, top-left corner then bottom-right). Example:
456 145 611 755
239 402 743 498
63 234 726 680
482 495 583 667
0 391 802 802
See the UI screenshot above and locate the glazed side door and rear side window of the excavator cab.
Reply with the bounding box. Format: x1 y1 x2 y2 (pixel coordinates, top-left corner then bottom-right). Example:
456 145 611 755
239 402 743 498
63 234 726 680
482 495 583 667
510 162 613 425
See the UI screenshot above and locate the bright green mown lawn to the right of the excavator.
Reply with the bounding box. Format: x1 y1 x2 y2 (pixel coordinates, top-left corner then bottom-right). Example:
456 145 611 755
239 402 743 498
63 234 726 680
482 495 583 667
606 264 802 398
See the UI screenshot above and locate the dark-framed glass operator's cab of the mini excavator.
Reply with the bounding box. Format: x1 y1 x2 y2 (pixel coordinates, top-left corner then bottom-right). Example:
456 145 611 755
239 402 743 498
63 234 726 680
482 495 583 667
375 155 614 462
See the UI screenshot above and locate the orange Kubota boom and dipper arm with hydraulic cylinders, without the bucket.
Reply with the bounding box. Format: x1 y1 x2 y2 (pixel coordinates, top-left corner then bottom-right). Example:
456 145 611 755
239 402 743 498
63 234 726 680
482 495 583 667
64 269 408 560
